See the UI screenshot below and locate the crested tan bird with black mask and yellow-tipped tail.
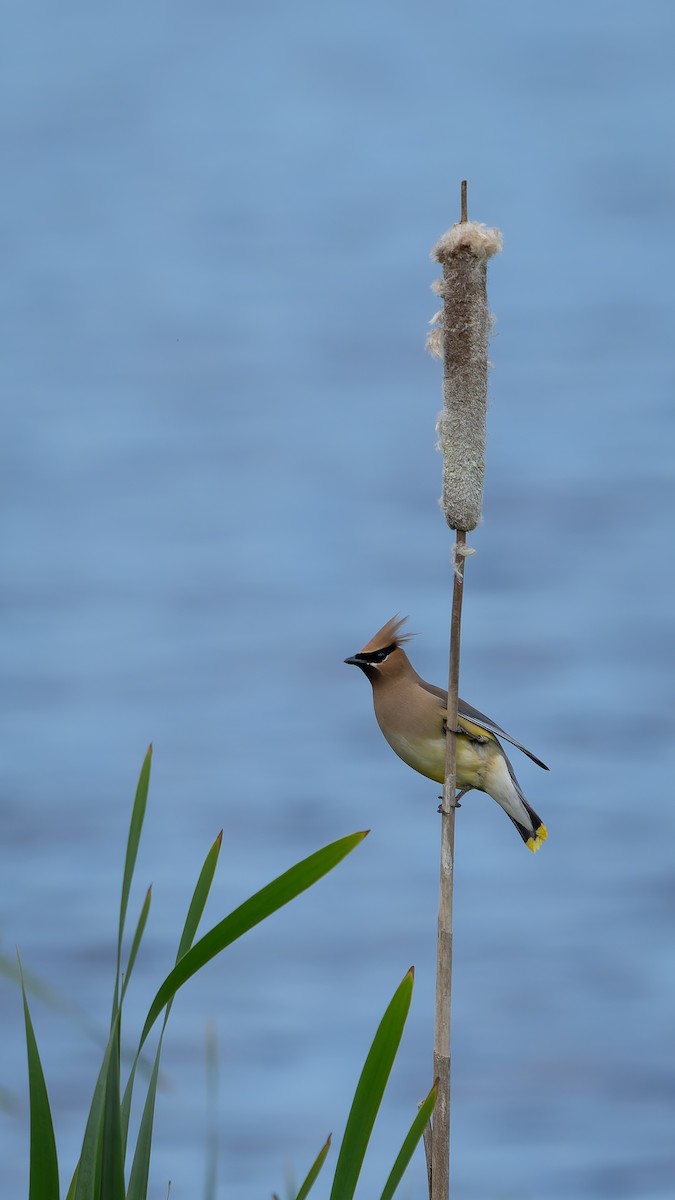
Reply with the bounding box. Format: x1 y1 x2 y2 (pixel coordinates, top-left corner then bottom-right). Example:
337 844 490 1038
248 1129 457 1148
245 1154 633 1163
345 614 549 852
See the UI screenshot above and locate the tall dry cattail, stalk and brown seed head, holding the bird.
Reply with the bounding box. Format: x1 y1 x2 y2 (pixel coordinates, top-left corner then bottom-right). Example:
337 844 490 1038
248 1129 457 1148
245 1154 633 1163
425 181 502 1200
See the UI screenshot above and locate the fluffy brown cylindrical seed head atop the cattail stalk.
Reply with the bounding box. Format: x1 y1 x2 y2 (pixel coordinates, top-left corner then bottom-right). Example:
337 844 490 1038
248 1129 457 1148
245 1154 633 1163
426 221 502 532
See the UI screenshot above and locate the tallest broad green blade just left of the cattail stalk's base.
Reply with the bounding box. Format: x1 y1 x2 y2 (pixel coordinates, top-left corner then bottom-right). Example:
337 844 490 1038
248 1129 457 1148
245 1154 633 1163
330 967 413 1200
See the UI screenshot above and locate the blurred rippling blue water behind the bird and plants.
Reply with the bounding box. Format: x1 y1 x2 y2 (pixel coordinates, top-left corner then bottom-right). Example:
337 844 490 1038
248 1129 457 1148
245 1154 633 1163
0 0 675 1200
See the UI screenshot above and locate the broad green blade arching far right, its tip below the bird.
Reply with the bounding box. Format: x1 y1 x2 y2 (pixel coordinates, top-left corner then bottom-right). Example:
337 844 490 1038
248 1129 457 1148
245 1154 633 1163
138 833 366 1050
